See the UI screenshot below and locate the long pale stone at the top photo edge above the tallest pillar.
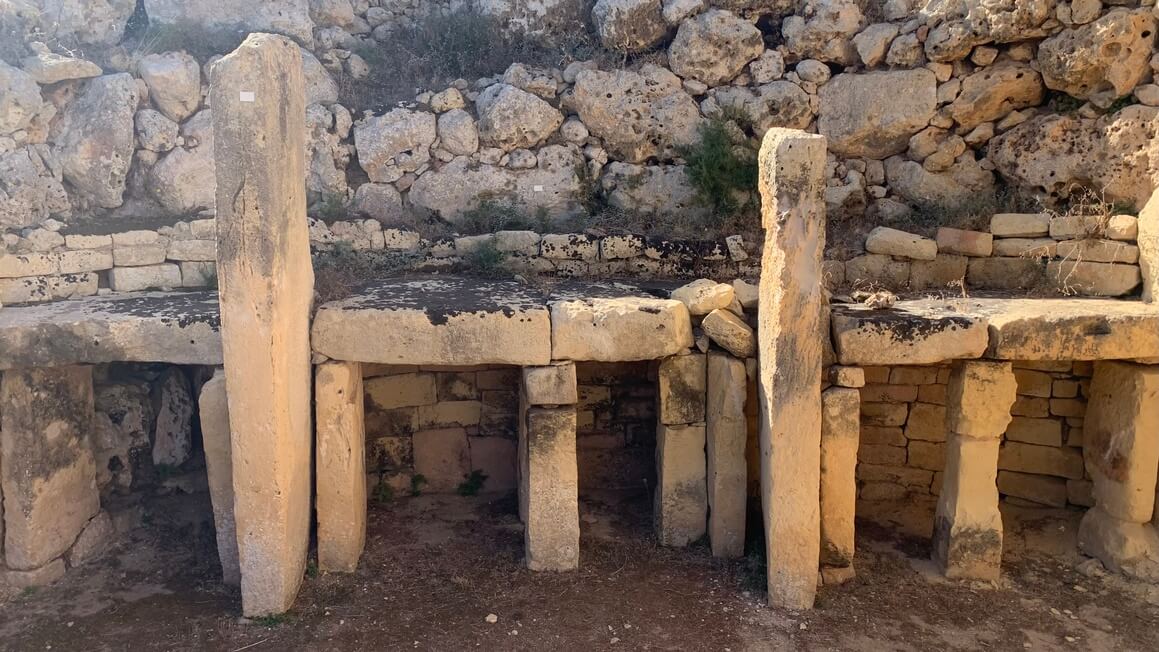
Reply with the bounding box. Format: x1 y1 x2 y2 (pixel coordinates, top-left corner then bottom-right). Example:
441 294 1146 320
144 0 314 47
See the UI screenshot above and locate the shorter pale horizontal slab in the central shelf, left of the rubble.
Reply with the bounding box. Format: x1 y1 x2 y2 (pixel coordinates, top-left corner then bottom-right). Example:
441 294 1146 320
551 296 692 361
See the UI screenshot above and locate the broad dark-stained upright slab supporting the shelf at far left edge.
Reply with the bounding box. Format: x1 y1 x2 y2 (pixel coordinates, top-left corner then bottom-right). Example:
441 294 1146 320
0 366 101 574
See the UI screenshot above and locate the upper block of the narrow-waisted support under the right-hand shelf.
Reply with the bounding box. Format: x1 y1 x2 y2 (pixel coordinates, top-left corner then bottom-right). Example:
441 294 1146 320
946 361 1018 440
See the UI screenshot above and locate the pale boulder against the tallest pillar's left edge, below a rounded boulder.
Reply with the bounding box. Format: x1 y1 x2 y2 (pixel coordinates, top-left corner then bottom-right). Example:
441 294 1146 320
146 109 217 215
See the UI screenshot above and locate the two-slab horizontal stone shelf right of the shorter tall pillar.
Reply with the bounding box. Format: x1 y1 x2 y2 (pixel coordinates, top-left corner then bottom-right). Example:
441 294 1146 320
832 298 1159 366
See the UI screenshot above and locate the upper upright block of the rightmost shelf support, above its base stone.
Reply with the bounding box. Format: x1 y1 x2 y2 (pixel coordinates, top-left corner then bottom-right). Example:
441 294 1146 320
1076 361 1159 522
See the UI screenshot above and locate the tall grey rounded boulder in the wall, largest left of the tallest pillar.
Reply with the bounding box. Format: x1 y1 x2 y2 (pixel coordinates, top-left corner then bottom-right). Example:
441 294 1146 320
53 73 137 208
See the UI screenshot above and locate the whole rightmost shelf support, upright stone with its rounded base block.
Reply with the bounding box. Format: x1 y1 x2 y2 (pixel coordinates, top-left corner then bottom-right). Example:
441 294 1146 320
1079 361 1159 579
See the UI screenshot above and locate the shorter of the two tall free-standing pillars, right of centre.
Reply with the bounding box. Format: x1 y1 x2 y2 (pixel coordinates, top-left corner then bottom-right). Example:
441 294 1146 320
757 129 825 609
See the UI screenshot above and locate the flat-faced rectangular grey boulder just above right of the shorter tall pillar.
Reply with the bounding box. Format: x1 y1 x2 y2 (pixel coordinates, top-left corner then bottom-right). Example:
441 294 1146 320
817 68 938 159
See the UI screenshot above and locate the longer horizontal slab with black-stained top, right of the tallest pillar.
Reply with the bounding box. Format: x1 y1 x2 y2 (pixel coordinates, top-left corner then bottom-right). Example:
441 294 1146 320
312 277 552 366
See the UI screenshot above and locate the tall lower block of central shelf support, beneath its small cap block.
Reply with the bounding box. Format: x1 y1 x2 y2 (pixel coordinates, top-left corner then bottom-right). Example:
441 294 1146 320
519 406 580 571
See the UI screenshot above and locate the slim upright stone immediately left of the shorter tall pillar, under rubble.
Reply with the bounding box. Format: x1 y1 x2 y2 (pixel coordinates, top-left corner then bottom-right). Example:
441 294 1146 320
705 351 749 557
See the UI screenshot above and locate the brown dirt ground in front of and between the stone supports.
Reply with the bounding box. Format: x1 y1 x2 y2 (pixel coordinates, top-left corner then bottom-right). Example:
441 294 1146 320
0 496 1159 652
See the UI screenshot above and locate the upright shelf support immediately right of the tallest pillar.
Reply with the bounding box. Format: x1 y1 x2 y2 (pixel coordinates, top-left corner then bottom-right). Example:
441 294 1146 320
314 361 366 573
